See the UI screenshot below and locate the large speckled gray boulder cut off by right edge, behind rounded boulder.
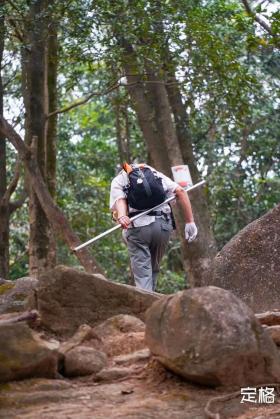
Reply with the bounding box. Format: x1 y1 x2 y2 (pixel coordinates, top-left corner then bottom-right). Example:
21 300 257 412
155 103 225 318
211 205 280 312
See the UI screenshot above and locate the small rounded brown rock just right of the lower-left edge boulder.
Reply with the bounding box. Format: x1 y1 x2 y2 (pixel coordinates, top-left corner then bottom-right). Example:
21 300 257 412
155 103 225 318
64 346 107 377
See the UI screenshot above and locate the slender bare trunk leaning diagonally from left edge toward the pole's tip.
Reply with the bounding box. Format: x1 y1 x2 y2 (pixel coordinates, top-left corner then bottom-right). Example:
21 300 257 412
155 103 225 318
0 117 103 274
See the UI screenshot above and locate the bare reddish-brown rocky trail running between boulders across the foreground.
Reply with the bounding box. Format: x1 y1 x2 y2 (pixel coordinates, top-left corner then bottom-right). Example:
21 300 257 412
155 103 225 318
0 319 280 419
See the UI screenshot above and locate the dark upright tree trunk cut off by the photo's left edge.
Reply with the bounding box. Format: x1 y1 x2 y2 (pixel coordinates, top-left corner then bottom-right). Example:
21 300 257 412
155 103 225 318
0 1 9 278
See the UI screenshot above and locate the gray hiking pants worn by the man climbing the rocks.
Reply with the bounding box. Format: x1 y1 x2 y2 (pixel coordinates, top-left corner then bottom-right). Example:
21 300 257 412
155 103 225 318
125 215 173 291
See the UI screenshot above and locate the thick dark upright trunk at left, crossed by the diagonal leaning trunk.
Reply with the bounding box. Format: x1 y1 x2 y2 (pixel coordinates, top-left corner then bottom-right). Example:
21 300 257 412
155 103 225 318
25 0 55 276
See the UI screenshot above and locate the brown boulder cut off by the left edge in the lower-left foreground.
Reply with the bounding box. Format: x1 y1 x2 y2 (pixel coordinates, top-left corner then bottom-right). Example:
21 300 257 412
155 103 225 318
0 323 58 382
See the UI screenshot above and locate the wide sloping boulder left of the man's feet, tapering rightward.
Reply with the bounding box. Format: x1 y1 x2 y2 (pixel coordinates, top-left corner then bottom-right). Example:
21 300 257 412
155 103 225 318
30 266 161 336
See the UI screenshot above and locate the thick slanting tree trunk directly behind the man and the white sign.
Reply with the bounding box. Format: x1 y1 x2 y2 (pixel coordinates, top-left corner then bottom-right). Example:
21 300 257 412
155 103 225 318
123 41 215 286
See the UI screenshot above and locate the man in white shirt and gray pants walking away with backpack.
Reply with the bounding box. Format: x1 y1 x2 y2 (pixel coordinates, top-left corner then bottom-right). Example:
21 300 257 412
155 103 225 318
110 163 197 291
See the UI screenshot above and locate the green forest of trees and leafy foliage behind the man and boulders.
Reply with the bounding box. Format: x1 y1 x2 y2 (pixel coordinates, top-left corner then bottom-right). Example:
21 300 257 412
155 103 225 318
0 0 280 293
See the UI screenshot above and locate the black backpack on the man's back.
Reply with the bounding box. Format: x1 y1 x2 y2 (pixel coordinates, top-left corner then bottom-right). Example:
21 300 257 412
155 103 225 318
124 165 166 210
